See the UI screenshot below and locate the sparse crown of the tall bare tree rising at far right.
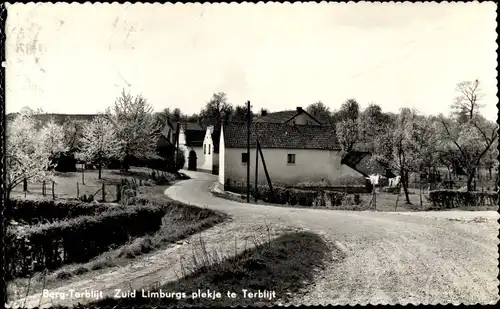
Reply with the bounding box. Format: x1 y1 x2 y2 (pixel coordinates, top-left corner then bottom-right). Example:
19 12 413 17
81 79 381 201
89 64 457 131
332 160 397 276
451 79 484 120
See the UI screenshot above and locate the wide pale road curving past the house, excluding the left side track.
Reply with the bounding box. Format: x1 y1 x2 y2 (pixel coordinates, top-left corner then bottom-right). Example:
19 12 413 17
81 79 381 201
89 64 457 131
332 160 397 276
165 171 499 305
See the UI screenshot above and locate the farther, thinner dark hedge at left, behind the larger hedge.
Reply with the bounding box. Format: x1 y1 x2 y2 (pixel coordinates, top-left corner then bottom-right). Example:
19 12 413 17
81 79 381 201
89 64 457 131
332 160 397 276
4 199 123 224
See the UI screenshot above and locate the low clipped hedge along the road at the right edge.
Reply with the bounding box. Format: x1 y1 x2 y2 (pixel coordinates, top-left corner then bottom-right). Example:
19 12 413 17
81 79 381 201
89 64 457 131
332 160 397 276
428 190 498 208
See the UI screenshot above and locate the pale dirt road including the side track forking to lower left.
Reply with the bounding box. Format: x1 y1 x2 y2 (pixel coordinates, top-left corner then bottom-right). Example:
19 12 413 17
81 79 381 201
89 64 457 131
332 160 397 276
11 172 499 307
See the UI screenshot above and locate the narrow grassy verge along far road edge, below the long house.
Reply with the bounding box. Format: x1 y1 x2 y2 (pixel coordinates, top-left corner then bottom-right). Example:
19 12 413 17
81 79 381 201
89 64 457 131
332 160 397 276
212 185 498 212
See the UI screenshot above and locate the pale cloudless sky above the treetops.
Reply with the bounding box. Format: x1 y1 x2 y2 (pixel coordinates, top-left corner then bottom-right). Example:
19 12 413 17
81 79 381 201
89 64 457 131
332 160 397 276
4 2 498 120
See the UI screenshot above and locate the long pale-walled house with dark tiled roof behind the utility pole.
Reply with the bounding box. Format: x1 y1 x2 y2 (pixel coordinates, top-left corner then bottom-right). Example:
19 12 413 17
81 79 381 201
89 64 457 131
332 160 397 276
219 122 366 187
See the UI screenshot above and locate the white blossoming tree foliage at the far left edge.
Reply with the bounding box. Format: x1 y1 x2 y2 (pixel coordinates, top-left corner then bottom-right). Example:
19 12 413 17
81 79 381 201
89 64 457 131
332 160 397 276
5 108 53 198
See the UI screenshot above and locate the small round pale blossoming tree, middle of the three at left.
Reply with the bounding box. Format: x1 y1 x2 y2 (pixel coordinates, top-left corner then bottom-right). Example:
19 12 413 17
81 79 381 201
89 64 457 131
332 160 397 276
76 116 121 177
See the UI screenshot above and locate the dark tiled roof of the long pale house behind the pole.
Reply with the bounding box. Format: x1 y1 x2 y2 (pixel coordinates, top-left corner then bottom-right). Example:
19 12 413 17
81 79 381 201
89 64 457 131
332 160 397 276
224 122 340 150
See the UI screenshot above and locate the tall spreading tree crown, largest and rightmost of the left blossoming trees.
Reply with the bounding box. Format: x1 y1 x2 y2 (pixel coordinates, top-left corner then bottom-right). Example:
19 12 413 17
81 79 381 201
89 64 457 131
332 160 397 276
106 91 162 168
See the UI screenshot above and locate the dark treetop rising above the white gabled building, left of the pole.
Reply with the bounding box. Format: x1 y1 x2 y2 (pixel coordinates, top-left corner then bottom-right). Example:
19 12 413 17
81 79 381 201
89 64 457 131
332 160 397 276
200 92 233 127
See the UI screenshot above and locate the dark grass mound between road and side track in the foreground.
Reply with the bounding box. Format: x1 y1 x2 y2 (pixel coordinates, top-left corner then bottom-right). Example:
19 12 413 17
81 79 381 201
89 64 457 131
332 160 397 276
89 232 332 307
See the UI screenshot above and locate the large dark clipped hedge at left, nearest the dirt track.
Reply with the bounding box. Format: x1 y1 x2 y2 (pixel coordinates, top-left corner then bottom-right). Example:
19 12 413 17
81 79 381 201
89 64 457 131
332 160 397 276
4 205 167 278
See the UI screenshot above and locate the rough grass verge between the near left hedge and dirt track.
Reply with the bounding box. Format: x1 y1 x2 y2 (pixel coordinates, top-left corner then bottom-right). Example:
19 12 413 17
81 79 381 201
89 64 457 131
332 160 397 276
7 179 229 300
